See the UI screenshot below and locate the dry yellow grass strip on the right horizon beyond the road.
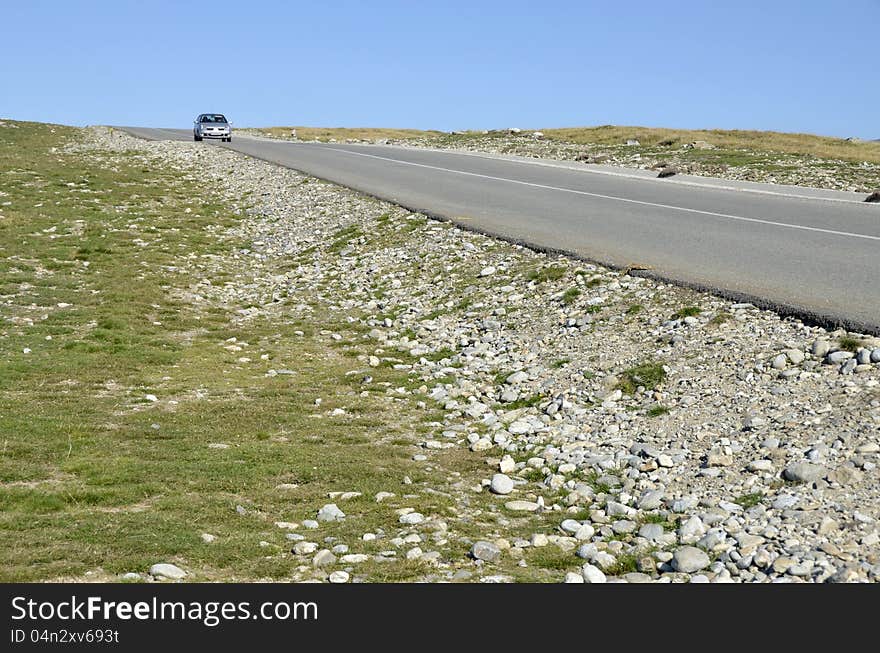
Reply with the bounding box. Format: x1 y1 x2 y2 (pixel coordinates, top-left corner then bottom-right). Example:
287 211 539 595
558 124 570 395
541 125 880 163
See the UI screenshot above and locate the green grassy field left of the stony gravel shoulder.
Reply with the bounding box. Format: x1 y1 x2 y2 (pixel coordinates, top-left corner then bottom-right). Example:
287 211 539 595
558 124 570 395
0 123 576 582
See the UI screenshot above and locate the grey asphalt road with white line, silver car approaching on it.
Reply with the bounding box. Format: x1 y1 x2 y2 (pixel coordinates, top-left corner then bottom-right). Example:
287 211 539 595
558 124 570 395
123 128 880 334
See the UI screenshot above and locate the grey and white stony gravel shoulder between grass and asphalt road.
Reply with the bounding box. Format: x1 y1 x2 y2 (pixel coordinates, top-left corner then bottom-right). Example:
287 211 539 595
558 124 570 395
0 121 880 583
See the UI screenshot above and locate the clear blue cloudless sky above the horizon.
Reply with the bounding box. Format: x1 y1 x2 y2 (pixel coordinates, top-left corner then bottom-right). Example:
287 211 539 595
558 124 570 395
0 0 880 138
